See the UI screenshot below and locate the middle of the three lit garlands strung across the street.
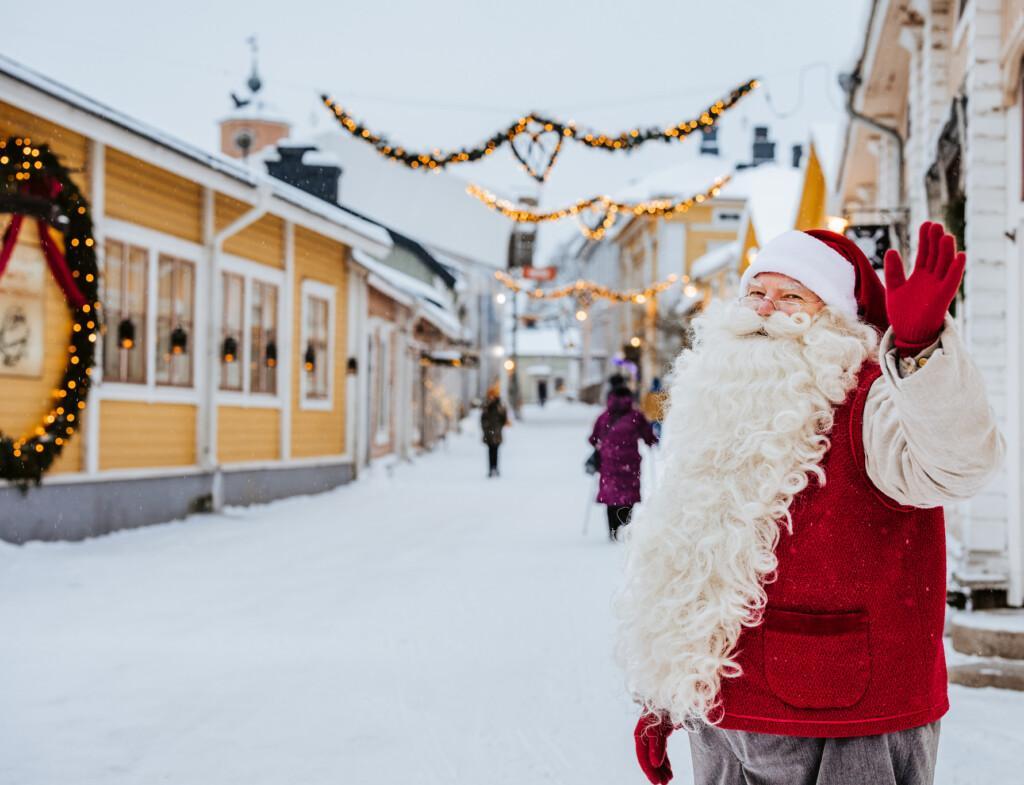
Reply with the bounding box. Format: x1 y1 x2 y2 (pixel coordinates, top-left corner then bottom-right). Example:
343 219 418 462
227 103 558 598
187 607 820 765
466 175 731 241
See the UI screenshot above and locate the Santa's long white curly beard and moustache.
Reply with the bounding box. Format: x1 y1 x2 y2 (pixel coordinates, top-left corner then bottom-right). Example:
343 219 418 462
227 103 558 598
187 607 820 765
615 304 878 725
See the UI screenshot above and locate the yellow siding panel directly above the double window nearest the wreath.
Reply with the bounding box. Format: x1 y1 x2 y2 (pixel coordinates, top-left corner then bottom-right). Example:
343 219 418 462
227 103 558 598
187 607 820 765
105 147 203 243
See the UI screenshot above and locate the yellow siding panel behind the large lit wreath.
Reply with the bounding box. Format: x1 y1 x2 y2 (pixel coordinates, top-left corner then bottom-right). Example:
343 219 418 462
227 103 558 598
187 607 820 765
0 227 83 472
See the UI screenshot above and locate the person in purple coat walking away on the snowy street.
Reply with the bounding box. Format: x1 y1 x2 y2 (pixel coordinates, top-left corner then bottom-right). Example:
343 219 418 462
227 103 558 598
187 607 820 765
590 379 657 539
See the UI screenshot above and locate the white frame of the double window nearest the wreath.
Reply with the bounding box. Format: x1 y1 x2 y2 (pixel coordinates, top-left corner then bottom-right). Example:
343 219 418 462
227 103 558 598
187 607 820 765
95 218 209 405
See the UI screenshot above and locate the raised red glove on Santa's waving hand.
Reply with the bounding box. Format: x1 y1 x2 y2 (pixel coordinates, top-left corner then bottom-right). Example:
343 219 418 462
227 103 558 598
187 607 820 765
885 221 967 356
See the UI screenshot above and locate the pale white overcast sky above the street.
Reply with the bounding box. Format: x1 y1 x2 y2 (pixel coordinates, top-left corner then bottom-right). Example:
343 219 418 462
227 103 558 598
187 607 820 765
0 0 867 264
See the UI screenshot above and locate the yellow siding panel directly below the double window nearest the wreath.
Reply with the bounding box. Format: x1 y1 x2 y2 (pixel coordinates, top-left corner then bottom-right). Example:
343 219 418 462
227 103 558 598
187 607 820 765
99 400 197 469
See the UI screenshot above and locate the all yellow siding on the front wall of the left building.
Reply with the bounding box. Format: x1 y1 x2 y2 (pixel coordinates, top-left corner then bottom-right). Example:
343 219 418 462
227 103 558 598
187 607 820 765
0 102 360 491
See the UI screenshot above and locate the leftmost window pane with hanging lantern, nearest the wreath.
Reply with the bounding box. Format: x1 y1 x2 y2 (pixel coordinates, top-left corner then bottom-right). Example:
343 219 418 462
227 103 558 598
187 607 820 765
102 239 150 384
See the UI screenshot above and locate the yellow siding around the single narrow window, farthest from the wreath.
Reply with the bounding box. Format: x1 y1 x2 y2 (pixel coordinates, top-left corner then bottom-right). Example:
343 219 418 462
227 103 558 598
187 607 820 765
292 226 348 457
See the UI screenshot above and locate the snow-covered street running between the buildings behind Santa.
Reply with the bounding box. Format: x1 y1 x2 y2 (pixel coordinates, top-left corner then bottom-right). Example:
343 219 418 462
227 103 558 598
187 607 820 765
0 405 1024 785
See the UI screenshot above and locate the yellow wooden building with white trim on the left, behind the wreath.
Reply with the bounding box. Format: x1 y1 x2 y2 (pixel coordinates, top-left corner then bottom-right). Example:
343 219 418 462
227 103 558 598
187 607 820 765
0 60 391 541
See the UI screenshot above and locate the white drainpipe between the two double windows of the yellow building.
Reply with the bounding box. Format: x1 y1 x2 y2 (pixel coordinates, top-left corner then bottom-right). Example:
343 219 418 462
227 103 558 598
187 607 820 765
200 186 271 512
